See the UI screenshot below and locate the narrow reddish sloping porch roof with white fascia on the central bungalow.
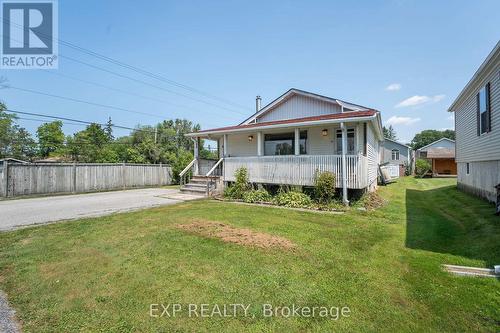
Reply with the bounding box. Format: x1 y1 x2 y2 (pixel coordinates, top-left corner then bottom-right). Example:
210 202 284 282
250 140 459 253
186 110 378 137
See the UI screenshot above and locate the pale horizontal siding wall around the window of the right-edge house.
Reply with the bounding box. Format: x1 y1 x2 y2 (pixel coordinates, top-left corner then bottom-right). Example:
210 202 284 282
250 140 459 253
455 61 500 162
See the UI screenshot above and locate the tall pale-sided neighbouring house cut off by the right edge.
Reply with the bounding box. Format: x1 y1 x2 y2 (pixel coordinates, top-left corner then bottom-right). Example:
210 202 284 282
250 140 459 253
448 42 500 202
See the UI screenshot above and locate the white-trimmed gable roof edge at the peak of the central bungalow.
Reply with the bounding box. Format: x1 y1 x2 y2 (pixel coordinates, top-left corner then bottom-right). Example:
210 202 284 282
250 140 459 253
240 88 372 125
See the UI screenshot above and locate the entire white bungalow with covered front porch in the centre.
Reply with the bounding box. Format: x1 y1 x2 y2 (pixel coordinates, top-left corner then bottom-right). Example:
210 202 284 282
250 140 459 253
181 89 383 203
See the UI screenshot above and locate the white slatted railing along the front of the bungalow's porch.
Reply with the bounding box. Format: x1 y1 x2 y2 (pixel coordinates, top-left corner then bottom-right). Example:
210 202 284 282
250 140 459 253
224 155 368 189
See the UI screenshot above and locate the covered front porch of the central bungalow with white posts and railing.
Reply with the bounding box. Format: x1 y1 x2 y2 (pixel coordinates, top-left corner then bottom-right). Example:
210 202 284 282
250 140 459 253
185 118 377 203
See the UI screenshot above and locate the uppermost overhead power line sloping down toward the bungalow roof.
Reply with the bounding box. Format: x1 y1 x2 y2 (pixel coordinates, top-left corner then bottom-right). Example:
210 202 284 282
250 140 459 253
2 18 248 110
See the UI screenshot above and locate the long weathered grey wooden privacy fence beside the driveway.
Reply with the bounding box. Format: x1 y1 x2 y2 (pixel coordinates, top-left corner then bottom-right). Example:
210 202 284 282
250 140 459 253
0 163 172 197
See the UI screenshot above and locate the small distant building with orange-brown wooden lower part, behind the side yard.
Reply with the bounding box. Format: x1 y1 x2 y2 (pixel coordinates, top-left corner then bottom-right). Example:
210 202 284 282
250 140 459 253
416 138 457 177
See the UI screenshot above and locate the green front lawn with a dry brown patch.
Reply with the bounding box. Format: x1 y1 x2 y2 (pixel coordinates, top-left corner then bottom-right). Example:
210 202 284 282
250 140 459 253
0 178 500 332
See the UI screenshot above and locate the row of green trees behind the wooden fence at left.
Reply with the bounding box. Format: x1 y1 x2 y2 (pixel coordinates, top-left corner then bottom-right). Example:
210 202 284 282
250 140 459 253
0 103 217 182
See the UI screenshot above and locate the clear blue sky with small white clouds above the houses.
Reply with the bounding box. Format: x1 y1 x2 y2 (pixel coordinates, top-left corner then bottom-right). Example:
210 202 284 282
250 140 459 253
0 0 500 142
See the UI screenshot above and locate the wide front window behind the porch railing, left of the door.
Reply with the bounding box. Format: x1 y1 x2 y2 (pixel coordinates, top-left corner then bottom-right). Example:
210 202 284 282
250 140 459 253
264 131 307 156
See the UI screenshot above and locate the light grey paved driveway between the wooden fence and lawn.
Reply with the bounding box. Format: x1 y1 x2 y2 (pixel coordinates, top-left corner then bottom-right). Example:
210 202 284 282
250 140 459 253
0 188 203 231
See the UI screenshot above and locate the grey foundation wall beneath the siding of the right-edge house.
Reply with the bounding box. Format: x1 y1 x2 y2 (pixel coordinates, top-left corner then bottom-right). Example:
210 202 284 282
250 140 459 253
457 160 500 202
